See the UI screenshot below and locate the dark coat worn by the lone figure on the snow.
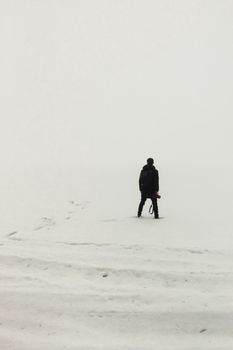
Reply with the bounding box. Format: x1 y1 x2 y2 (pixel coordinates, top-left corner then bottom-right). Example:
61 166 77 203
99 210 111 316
139 165 159 198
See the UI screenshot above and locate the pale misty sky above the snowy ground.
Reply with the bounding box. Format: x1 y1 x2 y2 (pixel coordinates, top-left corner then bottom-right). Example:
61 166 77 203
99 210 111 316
0 0 233 168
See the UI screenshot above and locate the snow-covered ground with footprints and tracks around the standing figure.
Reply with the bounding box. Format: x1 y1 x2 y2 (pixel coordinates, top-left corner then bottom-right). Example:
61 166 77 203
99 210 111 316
0 166 233 350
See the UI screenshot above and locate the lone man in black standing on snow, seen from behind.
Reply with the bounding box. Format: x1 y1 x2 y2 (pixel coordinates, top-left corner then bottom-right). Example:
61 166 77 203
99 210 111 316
138 158 159 219
